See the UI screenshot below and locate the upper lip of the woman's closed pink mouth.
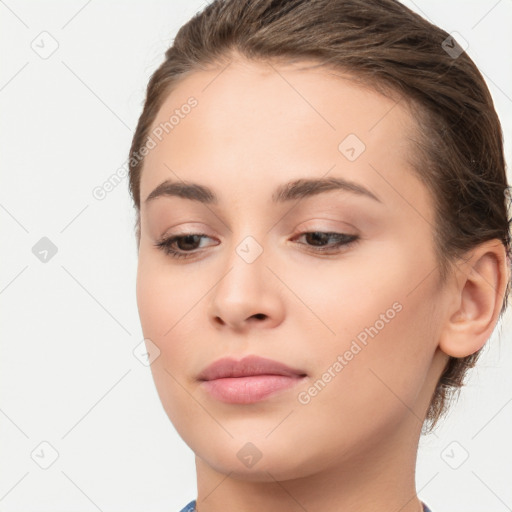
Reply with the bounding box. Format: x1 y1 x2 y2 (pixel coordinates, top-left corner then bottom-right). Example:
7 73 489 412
198 355 306 380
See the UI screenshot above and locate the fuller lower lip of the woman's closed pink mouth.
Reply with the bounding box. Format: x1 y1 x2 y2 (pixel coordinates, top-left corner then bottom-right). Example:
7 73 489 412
202 375 304 404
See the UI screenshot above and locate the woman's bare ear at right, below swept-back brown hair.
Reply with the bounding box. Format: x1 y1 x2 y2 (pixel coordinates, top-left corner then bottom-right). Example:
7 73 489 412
439 239 510 358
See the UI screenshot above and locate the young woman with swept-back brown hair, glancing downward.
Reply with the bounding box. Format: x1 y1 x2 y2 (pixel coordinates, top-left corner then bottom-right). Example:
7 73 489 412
126 0 510 512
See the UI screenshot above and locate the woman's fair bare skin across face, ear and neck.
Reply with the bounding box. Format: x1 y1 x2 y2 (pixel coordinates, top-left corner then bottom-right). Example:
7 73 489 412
137 58 506 512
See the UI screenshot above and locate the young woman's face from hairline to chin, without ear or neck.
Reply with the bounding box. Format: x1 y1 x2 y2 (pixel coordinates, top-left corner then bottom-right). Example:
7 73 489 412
137 61 447 480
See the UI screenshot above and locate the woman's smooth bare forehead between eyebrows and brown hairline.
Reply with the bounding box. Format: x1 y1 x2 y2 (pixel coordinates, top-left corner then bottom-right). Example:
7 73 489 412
141 60 428 214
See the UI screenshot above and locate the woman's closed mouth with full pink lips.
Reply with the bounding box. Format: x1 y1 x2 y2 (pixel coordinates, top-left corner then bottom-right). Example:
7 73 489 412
198 356 307 404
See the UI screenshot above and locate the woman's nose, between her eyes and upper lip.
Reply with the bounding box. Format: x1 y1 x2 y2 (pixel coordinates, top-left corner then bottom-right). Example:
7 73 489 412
209 243 284 332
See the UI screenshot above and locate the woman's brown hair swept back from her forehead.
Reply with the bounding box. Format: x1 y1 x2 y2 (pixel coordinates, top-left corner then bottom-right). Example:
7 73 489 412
129 0 511 432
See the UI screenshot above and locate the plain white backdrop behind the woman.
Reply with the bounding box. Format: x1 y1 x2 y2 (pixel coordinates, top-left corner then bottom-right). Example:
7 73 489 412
0 0 512 512
